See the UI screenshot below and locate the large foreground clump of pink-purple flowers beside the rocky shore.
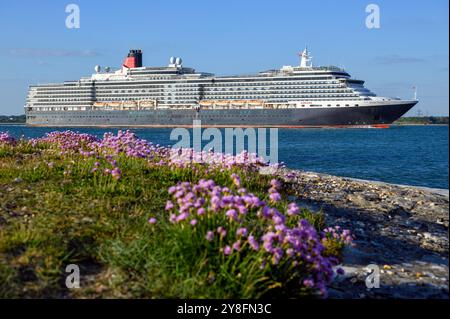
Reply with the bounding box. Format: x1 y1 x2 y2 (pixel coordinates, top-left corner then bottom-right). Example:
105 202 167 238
165 175 348 295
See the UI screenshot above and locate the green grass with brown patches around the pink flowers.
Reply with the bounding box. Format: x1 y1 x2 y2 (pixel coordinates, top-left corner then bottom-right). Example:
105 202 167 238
0 141 336 298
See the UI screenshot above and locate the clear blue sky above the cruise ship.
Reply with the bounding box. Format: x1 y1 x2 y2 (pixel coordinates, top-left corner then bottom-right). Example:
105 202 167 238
0 0 449 115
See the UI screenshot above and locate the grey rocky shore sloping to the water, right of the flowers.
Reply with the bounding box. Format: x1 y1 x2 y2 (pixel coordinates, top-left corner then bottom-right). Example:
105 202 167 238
268 169 449 298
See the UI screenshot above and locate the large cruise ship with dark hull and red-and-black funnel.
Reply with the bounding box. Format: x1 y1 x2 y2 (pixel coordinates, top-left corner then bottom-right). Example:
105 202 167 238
25 48 418 127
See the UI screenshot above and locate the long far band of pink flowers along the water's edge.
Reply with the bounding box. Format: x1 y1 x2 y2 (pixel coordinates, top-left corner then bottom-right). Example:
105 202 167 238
30 130 280 180
